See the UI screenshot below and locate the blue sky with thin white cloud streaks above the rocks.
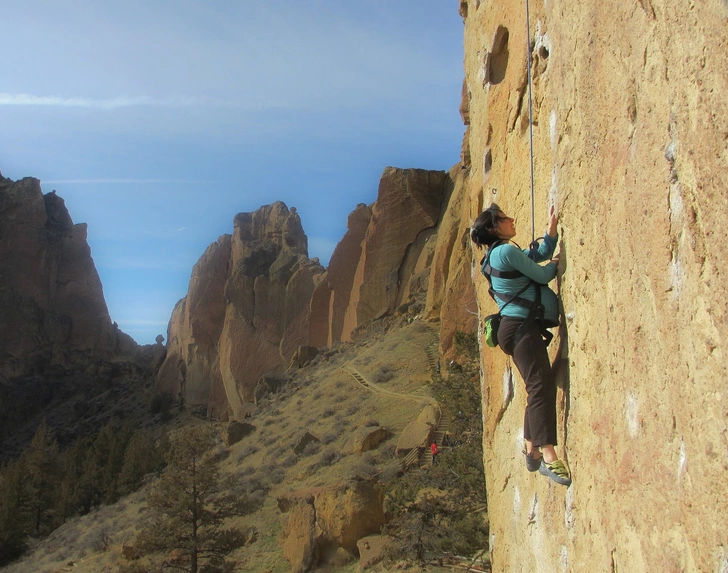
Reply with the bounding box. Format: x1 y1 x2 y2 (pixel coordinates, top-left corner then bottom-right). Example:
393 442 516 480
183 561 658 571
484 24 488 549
0 0 464 344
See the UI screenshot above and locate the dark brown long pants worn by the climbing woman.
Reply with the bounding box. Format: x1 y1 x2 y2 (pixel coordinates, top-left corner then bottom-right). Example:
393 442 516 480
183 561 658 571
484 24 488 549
498 316 556 447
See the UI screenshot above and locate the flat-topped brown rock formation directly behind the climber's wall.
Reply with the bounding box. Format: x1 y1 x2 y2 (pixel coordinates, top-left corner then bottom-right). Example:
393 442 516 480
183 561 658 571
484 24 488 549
310 166 477 352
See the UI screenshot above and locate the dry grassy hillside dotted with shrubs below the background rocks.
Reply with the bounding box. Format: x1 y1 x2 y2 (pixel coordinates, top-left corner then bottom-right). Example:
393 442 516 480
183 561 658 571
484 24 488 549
3 316 490 573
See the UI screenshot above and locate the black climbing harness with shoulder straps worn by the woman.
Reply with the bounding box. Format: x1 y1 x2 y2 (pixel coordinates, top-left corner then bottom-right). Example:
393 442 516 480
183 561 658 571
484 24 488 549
480 241 554 347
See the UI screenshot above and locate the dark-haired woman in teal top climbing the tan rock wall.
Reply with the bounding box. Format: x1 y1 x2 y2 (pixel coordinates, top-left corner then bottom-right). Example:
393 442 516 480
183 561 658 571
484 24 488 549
470 203 571 486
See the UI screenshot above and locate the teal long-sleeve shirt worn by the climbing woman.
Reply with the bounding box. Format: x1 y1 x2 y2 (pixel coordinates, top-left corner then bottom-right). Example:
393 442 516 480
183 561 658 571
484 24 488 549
480 235 559 324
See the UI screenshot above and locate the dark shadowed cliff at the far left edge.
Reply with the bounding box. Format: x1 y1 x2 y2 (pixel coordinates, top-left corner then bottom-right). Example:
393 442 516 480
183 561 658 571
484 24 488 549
0 176 137 379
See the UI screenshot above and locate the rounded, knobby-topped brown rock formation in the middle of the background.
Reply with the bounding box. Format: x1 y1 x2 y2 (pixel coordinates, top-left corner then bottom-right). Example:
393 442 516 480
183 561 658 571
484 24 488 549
157 202 324 419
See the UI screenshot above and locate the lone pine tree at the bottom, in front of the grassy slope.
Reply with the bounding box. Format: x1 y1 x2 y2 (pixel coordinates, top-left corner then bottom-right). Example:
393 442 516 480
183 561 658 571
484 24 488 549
139 426 244 573
